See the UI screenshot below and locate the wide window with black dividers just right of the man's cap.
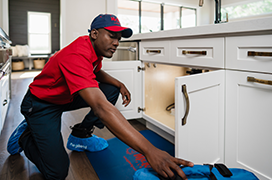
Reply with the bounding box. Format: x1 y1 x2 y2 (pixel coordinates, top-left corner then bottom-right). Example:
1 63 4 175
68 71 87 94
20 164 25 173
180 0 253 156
118 0 196 34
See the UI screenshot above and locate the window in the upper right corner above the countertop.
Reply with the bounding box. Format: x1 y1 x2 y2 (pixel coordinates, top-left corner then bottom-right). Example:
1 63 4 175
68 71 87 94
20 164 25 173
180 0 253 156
221 0 272 19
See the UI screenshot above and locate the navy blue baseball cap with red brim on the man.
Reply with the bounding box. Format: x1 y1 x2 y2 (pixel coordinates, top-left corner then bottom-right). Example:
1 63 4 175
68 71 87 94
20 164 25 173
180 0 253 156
88 14 133 38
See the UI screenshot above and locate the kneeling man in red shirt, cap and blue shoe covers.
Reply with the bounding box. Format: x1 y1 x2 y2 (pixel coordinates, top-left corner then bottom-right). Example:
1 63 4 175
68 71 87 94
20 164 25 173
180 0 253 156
7 14 193 179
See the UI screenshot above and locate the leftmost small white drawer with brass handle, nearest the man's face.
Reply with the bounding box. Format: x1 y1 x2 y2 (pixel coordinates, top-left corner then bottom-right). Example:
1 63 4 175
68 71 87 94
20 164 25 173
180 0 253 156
140 40 170 62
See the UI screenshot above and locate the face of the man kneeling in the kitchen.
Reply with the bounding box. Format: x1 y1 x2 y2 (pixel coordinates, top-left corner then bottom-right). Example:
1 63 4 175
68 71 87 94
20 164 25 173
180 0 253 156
91 28 122 58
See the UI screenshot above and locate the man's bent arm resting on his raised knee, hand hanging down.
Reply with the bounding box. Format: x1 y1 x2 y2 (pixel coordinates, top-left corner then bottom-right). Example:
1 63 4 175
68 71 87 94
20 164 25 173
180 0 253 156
95 70 131 107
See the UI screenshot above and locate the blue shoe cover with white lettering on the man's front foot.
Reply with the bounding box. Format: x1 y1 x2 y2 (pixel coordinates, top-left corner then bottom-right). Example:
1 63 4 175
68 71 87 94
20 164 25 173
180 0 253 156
67 134 109 152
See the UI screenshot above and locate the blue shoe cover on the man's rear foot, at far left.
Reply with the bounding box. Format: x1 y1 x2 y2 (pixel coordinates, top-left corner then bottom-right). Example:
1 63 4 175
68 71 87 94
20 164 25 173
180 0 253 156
7 119 27 155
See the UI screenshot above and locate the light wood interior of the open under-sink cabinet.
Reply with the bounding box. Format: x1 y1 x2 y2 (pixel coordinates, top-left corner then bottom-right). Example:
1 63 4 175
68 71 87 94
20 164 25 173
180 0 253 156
144 63 189 130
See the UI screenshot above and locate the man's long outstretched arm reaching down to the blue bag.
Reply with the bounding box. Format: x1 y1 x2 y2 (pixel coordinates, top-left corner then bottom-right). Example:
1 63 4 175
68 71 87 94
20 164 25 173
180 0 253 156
79 88 193 179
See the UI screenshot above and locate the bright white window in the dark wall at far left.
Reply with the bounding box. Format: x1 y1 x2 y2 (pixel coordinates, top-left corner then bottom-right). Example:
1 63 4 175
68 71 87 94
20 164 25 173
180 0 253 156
27 12 51 54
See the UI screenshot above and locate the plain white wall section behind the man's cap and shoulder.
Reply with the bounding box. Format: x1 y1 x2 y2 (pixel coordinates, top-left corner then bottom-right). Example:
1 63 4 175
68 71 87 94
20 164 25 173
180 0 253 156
60 0 117 48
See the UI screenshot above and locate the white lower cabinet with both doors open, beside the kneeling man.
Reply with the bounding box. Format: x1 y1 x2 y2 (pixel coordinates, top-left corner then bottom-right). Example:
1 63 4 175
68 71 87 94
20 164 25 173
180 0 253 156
103 58 225 160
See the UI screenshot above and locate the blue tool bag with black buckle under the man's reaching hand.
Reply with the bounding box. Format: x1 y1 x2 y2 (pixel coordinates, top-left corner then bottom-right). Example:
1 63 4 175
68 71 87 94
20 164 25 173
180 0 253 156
133 164 258 180
